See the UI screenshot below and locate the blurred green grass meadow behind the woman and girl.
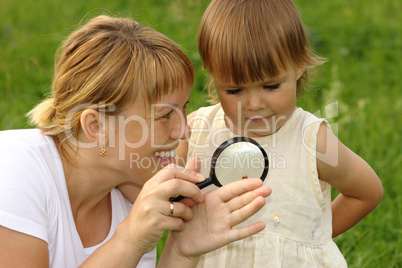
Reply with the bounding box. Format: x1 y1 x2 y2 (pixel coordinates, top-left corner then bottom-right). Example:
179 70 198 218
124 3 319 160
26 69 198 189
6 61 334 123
0 0 402 267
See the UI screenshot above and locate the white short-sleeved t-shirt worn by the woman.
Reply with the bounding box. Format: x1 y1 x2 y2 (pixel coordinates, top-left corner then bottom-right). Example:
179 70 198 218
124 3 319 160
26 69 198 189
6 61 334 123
0 129 156 267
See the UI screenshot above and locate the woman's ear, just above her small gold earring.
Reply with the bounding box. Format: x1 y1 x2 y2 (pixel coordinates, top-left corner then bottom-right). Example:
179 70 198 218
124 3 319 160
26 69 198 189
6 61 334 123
80 109 107 146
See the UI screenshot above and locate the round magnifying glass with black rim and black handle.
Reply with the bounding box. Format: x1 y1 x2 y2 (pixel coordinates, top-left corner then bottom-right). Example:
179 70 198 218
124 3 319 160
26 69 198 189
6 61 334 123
169 137 269 201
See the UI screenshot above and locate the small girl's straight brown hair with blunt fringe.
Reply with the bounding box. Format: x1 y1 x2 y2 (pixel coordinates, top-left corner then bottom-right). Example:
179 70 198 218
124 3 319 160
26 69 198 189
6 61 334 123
198 0 325 101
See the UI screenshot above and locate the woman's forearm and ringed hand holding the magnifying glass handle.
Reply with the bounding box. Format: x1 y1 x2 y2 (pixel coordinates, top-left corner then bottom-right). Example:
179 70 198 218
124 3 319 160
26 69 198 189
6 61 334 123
82 165 205 267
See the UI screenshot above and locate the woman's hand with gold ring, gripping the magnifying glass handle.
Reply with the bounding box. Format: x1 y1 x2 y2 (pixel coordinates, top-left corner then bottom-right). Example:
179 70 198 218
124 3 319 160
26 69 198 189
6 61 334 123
116 164 205 254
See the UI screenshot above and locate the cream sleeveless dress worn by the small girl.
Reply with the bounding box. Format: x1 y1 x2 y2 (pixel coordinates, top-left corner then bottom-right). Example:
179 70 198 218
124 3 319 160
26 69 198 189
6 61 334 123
187 104 347 268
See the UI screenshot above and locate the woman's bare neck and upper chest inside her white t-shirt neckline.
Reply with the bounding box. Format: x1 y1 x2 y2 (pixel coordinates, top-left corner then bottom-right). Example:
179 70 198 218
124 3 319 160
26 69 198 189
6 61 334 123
61 144 114 247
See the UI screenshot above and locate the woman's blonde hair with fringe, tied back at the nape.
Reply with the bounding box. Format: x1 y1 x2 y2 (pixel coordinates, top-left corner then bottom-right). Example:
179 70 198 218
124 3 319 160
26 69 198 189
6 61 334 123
28 15 194 155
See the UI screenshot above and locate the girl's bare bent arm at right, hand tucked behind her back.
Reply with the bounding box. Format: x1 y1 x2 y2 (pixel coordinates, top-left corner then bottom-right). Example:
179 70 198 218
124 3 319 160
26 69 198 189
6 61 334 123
317 124 383 237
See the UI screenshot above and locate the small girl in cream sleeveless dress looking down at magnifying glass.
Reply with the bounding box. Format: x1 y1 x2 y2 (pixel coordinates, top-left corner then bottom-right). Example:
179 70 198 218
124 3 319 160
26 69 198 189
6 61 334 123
178 0 383 268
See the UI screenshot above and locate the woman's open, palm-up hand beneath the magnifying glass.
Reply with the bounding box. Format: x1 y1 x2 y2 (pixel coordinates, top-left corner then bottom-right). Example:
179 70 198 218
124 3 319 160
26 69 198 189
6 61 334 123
161 179 271 266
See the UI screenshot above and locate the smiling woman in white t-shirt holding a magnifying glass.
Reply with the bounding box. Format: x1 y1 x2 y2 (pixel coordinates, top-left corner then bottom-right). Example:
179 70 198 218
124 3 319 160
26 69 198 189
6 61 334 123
0 16 270 267
